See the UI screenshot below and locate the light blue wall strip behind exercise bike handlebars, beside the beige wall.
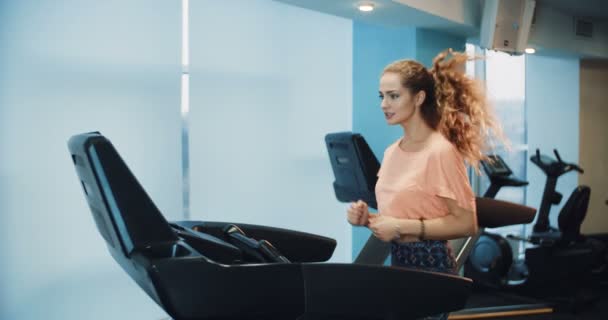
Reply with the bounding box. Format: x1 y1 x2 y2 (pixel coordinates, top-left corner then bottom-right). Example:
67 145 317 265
526 55 580 226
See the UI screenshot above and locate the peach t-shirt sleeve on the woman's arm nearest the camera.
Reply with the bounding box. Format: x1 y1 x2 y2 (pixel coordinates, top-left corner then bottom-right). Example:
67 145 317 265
426 148 475 211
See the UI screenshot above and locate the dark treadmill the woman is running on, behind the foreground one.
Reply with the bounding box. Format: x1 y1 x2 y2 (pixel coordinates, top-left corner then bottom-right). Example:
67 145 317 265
325 132 553 319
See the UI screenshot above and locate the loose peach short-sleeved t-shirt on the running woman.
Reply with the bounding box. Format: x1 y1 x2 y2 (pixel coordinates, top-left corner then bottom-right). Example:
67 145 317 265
376 132 475 219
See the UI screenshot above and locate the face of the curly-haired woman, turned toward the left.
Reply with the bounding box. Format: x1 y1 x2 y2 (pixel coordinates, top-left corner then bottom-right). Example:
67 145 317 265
379 72 416 125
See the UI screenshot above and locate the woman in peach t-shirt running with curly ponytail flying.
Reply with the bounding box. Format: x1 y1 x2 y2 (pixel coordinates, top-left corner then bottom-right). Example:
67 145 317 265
347 50 501 319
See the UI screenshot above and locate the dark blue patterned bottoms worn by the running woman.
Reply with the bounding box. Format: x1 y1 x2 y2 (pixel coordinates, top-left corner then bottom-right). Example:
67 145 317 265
391 240 457 320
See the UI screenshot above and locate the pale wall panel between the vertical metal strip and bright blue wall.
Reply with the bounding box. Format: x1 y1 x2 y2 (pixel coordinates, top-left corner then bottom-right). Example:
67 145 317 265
190 0 352 261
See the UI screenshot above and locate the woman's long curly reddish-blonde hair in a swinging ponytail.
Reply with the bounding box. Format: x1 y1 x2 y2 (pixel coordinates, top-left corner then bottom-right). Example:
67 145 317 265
383 49 508 173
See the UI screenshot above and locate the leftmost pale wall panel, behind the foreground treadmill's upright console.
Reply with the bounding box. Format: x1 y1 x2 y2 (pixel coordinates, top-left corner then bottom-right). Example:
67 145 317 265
0 0 181 320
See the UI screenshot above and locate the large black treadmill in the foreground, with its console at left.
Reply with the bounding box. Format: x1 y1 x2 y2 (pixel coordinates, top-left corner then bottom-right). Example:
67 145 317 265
68 132 472 320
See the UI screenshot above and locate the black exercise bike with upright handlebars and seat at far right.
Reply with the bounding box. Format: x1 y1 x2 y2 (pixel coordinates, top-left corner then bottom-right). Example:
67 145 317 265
526 149 606 290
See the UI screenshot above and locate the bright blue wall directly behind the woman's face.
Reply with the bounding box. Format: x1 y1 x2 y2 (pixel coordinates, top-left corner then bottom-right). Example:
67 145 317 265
352 22 465 258
